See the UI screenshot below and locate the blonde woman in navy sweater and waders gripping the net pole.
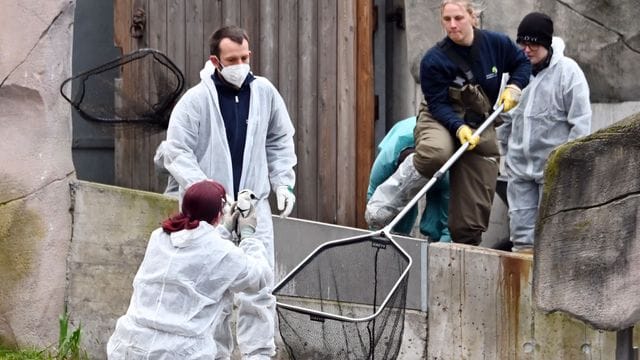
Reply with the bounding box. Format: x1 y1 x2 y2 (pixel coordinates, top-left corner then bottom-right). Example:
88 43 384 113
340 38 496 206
413 0 531 245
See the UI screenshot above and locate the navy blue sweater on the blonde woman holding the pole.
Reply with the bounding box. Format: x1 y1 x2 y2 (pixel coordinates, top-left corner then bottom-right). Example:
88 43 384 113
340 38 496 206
420 29 531 135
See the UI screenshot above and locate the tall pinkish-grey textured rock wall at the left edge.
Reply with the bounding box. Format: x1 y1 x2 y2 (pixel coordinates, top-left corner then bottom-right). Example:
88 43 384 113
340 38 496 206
0 0 75 346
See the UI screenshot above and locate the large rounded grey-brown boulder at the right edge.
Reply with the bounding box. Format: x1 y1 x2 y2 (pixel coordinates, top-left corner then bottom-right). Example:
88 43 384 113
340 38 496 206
534 114 640 330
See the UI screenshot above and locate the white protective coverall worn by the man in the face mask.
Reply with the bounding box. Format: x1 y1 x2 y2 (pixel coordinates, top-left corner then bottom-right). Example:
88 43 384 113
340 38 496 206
161 61 297 357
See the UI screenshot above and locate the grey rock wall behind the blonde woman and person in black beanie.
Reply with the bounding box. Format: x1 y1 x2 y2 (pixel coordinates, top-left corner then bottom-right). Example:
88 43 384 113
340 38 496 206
405 0 640 102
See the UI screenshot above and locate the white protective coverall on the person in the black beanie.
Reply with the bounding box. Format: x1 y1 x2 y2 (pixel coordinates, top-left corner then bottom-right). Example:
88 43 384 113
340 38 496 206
497 37 591 250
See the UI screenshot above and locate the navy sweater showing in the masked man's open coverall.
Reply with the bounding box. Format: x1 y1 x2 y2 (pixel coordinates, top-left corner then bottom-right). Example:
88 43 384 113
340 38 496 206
211 71 255 194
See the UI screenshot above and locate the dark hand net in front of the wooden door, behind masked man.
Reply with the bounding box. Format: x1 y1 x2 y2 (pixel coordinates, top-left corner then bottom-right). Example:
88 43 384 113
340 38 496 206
60 49 184 128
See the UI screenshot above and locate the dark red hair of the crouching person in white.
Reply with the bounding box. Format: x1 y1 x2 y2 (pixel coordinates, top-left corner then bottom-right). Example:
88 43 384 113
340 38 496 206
162 180 225 234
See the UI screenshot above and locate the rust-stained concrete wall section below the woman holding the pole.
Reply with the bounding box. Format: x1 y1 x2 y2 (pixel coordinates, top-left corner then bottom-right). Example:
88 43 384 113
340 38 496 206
428 244 616 360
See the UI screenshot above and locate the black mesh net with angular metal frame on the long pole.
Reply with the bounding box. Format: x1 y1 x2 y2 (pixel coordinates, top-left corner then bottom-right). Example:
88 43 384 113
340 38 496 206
273 232 411 360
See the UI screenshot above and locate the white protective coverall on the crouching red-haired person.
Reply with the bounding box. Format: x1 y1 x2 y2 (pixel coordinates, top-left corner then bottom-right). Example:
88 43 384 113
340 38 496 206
107 221 273 360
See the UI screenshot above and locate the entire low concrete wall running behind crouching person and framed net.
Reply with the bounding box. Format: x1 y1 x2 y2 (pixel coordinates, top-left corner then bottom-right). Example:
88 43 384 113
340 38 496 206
67 182 636 360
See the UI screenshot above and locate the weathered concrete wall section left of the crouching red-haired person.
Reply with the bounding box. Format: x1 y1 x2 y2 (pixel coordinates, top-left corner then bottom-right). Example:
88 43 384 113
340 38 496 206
67 181 178 359
